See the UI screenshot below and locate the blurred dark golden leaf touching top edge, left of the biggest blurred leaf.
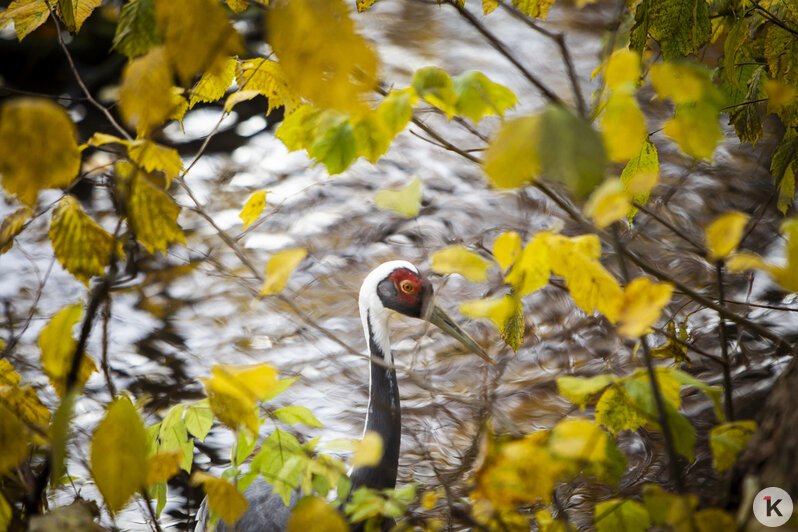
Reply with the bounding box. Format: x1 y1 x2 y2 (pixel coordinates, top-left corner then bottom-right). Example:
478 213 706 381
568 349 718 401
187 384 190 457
155 0 243 86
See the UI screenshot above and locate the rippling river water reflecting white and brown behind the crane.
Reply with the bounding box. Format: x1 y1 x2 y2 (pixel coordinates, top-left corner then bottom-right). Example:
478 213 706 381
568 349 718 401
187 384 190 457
0 0 795 530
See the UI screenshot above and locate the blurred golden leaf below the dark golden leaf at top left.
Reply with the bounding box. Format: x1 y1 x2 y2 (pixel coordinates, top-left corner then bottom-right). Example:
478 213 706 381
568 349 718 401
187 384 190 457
119 46 177 136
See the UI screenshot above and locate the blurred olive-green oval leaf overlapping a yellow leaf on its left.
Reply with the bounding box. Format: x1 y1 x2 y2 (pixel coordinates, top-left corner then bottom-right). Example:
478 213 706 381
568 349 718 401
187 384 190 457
538 105 607 197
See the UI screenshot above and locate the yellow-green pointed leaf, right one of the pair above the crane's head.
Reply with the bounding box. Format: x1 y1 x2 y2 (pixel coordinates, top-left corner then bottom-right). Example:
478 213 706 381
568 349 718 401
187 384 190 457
452 70 518 123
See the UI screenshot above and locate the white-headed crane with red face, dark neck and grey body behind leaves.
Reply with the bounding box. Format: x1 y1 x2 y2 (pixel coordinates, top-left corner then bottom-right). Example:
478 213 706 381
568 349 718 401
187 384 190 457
195 260 493 532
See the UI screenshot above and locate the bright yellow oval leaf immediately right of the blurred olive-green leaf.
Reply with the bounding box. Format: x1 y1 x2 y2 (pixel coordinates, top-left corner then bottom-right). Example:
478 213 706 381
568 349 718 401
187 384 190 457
601 92 648 162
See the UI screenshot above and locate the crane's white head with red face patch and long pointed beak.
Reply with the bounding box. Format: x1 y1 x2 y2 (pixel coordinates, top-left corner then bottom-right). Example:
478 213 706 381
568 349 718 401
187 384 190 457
359 260 493 364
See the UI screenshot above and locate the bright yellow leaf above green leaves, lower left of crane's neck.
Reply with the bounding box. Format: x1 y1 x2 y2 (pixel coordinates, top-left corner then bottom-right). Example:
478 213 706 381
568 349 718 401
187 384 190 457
200 364 277 434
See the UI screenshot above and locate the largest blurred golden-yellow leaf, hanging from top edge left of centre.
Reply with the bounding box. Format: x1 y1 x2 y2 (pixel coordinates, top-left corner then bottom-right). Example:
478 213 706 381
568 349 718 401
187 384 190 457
267 0 377 111
